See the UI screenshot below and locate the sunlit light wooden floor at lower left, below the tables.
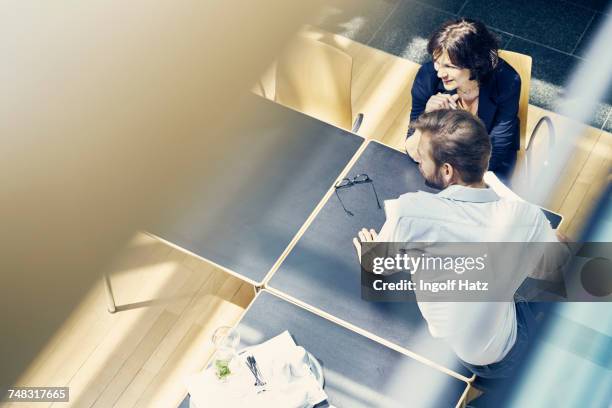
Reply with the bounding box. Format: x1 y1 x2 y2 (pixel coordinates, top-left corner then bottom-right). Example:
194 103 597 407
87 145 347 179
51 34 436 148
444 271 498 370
0 234 254 408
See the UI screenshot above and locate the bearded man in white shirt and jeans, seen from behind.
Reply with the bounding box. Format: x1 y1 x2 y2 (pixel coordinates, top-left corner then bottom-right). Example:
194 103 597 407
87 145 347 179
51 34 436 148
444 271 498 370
353 109 568 389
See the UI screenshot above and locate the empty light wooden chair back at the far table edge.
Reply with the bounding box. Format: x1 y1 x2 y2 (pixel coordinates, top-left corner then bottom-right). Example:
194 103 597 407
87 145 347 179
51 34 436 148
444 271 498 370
274 37 363 133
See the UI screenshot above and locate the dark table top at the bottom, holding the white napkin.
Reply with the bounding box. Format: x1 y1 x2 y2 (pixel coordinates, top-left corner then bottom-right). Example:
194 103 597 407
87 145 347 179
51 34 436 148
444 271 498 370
212 290 467 408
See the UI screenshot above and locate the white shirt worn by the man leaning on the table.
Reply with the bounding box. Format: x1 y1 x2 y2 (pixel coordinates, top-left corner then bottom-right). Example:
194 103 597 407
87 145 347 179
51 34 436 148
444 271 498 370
377 185 557 365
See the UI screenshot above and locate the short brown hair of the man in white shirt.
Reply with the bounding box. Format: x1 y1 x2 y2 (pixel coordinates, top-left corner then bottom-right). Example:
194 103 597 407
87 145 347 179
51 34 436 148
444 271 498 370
411 109 491 183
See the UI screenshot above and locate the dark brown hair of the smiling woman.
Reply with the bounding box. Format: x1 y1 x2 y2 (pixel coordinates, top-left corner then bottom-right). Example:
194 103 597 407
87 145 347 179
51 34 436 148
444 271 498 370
427 18 499 83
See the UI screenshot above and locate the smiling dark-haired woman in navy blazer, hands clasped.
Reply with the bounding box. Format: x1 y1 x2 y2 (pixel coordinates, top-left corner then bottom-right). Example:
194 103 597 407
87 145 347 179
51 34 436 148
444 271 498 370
406 18 521 179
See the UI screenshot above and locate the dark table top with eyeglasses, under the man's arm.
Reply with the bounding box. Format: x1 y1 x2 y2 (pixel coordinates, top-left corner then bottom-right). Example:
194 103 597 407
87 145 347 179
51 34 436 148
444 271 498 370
268 142 471 378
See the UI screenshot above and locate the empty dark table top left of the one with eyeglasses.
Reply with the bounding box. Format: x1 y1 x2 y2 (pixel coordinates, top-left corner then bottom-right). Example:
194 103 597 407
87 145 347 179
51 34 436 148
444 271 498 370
151 95 364 284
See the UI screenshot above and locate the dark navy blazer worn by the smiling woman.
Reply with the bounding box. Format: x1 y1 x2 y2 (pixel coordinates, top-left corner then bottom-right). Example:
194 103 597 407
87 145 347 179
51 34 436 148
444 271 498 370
408 58 521 177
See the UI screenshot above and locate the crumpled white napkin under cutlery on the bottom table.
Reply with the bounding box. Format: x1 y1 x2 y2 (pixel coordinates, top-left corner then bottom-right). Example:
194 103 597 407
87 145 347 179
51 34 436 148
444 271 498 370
187 331 327 408
